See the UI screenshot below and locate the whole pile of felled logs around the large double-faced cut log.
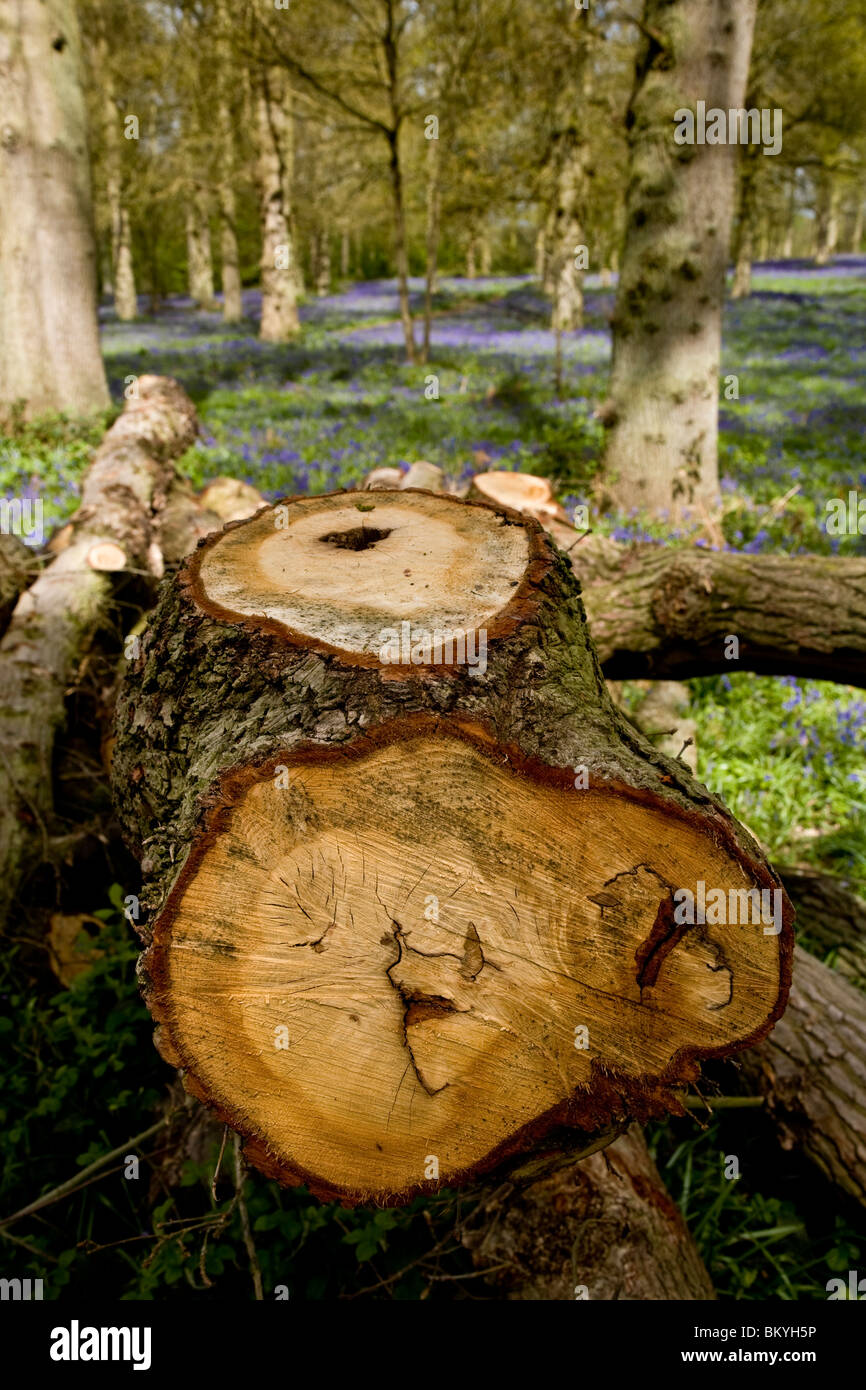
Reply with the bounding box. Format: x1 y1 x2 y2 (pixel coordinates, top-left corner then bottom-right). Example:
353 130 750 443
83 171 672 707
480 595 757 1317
8 378 866 1298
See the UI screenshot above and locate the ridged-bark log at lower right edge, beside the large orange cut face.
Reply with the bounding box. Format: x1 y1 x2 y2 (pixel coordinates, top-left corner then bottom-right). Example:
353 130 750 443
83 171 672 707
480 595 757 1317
741 947 866 1205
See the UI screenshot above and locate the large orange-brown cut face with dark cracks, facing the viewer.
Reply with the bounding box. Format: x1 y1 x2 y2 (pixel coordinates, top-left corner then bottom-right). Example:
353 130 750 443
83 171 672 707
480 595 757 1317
150 733 780 1200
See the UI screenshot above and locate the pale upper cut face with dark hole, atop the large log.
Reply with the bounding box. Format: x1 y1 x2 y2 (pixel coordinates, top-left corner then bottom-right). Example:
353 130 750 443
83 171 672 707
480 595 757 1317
199 492 530 656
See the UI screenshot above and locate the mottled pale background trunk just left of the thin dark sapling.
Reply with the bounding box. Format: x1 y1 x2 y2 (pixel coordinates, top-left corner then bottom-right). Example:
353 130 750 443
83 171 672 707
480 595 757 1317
256 68 300 343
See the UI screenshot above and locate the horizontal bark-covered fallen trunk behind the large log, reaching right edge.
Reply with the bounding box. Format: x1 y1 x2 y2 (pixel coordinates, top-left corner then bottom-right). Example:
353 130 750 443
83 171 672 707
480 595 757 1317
549 521 866 685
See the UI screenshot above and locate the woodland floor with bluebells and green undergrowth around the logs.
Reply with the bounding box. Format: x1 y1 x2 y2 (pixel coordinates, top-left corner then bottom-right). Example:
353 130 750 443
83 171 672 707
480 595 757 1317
0 257 866 1300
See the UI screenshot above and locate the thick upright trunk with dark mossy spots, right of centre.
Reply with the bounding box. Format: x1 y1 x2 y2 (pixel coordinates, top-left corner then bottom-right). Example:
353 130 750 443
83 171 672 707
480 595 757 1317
603 0 755 513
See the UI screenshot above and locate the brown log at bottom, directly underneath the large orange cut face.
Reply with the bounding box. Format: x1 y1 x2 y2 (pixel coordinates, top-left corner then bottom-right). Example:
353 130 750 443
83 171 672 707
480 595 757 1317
463 1126 716 1302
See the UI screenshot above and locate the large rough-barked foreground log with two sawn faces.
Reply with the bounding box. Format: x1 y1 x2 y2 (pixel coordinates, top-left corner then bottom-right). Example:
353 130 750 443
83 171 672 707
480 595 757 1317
113 492 791 1202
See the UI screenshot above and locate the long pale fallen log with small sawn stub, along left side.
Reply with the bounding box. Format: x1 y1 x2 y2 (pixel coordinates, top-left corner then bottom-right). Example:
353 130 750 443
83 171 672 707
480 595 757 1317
0 377 197 923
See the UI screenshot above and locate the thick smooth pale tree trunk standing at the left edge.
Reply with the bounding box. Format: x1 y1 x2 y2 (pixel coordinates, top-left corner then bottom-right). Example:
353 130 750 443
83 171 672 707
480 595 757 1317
0 0 108 417
